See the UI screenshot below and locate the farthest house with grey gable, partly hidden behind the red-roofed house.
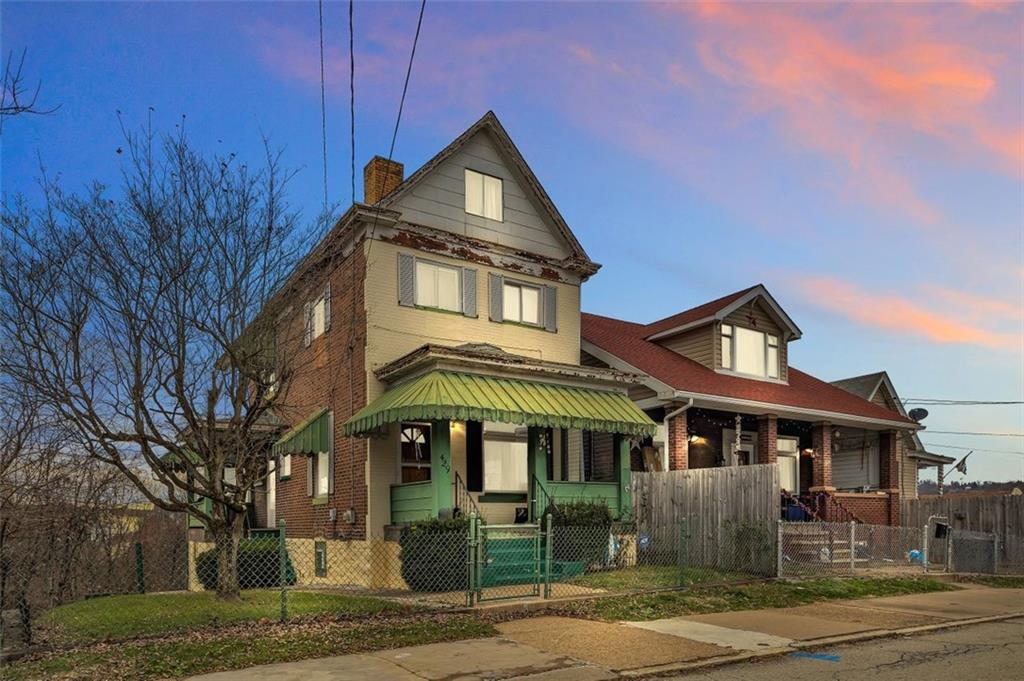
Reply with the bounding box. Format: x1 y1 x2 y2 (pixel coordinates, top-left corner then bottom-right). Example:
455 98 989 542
833 372 955 499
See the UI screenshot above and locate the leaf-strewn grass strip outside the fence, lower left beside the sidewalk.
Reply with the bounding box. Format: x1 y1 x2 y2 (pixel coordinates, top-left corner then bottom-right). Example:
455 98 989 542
3 615 497 681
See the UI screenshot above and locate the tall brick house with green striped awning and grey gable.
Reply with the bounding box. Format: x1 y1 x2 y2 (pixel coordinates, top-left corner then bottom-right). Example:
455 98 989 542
258 113 655 585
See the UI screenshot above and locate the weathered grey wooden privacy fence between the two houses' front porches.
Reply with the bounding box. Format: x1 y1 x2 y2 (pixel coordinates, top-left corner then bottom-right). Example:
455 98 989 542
632 464 780 572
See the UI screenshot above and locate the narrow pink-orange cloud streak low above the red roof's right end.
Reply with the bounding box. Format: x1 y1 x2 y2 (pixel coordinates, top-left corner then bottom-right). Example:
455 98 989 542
797 276 1024 352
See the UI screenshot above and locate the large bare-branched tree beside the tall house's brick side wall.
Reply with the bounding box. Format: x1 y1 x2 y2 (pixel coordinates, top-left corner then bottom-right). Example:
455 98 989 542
0 124 311 598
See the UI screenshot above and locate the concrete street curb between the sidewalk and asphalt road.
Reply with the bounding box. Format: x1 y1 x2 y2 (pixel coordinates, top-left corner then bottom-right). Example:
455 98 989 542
618 611 1024 678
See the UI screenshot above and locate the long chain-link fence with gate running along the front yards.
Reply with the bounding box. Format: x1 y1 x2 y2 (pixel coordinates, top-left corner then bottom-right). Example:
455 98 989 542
12 515 1019 644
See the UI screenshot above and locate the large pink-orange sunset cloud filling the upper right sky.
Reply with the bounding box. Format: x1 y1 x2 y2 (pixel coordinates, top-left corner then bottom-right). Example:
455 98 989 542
673 2 1024 223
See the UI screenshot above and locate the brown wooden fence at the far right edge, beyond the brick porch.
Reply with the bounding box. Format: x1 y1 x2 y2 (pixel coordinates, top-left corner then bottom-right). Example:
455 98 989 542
900 495 1024 571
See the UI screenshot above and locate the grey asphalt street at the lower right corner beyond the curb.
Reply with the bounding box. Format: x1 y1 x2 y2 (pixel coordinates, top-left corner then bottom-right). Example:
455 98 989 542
671 618 1024 681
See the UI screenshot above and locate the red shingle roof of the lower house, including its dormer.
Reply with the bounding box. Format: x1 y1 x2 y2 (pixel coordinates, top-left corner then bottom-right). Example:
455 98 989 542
581 313 915 425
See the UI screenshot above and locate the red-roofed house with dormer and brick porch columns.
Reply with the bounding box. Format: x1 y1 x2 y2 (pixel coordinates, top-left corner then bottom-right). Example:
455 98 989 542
582 285 921 524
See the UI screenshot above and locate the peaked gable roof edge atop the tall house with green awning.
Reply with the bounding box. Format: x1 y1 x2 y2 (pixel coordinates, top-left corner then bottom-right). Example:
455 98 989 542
379 111 600 274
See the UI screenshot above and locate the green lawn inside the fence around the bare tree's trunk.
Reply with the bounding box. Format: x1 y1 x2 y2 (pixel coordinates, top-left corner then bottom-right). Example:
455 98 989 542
36 589 412 641
